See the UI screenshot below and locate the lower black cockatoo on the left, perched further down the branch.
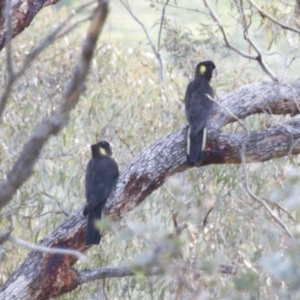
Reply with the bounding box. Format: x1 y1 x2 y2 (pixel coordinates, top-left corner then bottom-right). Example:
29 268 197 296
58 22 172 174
83 141 119 245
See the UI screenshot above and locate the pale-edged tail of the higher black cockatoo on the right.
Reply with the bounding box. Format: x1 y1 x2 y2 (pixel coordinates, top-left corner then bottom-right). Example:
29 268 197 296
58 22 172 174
187 128 206 165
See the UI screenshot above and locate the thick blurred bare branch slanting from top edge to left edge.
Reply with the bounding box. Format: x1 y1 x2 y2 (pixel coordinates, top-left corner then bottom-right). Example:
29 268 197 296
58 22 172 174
0 1 108 209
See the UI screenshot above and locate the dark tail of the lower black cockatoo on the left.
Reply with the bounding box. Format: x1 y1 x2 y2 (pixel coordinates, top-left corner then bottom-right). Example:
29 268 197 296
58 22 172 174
85 205 102 245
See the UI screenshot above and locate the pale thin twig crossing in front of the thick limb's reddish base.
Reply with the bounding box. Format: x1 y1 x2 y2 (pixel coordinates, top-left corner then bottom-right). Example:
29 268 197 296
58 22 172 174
8 235 89 262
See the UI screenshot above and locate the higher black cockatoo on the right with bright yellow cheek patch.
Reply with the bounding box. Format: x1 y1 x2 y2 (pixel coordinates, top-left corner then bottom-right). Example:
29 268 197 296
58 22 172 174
184 61 217 165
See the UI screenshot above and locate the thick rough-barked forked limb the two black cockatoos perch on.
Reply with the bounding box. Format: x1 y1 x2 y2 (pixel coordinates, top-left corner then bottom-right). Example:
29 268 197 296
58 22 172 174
0 81 300 300
